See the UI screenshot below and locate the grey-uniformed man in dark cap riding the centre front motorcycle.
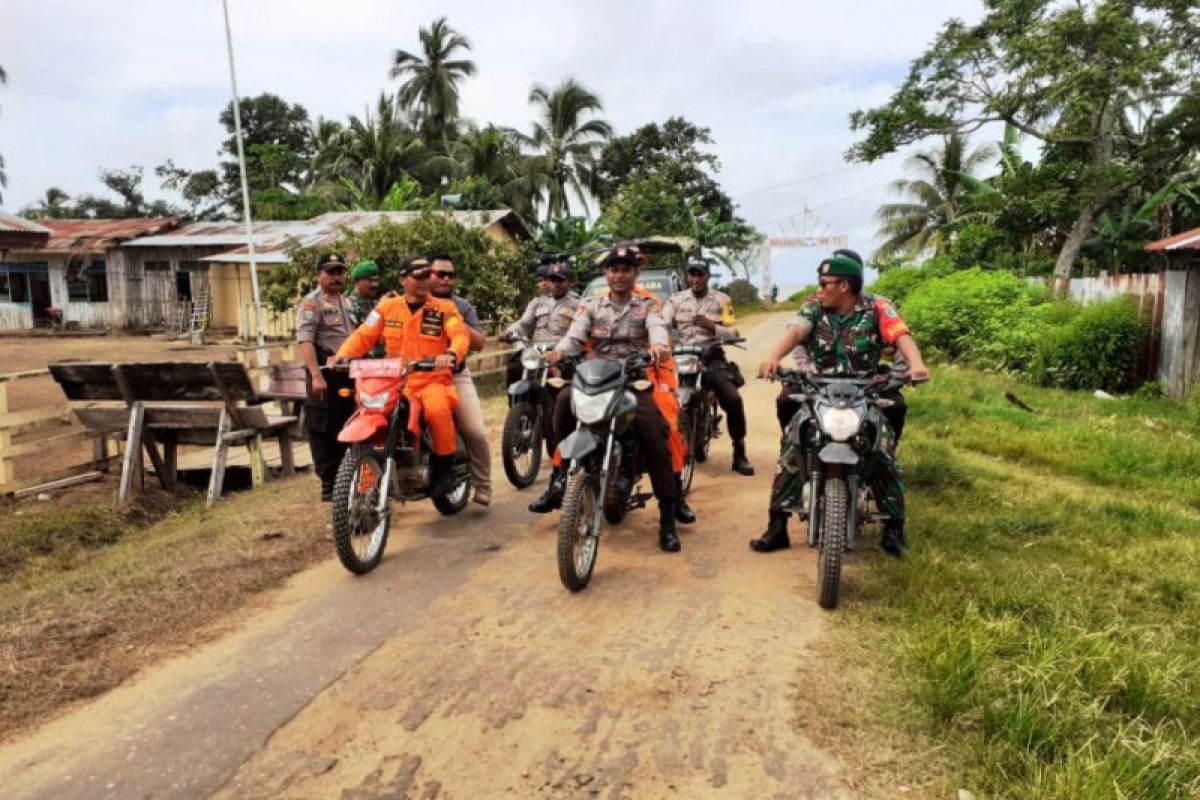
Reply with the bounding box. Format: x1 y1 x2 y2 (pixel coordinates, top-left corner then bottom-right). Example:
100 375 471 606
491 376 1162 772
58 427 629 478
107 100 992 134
540 245 682 553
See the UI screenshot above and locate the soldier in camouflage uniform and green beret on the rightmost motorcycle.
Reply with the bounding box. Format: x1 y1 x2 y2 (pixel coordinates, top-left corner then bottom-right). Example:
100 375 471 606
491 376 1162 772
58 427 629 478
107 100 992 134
750 255 929 557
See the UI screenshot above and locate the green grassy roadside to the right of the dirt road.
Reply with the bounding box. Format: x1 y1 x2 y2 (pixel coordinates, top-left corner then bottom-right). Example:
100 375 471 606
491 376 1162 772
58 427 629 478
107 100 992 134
799 368 1200 800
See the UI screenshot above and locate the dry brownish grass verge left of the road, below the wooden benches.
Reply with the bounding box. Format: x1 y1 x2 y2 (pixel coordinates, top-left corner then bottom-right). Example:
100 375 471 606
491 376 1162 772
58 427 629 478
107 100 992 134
0 476 330 738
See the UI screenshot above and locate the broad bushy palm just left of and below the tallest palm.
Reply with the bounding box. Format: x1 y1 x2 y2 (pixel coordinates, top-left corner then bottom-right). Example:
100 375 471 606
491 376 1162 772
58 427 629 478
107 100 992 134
317 95 428 207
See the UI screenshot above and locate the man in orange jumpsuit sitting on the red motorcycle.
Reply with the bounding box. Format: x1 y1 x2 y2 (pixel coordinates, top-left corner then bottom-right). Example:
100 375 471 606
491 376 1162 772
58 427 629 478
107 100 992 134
331 257 470 494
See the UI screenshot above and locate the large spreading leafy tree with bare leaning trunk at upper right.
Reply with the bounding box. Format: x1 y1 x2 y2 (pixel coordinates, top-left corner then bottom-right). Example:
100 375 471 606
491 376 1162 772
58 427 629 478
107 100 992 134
847 0 1200 284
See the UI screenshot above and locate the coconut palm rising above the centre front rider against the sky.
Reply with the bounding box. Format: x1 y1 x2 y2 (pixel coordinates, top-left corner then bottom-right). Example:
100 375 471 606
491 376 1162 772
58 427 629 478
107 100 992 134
521 78 612 219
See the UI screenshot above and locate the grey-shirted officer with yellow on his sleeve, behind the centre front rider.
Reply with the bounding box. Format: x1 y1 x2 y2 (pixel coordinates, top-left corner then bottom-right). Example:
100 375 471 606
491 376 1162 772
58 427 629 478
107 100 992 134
662 260 754 475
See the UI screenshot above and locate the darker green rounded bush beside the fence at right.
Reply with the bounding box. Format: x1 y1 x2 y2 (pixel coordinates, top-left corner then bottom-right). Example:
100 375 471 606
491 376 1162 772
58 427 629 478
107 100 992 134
1033 297 1145 391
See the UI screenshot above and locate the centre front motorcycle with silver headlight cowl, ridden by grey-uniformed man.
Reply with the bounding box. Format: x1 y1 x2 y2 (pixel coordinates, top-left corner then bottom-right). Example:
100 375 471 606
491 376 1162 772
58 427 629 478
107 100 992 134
558 353 653 591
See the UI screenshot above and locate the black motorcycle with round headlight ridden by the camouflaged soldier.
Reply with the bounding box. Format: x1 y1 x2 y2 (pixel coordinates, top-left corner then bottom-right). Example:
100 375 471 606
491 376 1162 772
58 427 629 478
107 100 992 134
778 371 917 608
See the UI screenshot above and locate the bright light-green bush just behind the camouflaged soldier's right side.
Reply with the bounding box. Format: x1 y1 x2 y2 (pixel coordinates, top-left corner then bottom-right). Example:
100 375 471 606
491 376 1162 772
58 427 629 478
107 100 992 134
904 269 1055 369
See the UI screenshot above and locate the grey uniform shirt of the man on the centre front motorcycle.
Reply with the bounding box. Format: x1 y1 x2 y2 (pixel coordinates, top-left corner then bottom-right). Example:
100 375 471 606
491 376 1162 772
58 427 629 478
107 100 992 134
554 295 671 361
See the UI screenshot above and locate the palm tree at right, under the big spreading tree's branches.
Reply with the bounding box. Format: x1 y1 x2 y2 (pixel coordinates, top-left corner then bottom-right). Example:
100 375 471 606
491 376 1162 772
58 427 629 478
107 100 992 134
875 133 996 258
